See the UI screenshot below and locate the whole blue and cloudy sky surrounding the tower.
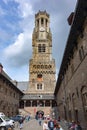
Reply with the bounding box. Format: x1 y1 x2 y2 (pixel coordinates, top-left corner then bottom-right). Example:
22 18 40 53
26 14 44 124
0 0 77 81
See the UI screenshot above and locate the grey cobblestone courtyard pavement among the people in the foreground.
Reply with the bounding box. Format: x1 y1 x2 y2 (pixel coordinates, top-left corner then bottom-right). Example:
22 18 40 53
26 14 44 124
14 119 68 130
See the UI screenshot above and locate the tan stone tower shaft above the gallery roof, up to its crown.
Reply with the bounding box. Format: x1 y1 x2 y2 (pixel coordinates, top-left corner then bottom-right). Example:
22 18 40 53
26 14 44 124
28 11 55 94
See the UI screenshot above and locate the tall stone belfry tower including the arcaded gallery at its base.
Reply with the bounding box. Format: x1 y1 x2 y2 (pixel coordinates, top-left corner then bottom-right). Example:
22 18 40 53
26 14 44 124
23 11 56 115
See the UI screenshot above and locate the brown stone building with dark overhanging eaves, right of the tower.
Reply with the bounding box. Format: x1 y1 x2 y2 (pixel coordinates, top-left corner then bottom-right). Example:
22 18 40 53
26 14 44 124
55 0 87 130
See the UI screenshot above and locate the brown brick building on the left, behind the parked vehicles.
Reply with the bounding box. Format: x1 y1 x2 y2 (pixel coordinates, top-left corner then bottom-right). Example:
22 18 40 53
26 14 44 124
0 64 23 117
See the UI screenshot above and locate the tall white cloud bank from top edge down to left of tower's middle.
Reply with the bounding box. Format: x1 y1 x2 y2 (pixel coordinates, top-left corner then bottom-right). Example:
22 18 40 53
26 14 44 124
3 0 33 67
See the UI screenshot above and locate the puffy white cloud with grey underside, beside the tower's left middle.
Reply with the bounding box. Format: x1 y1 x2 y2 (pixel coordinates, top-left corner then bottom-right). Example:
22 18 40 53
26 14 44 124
3 32 31 67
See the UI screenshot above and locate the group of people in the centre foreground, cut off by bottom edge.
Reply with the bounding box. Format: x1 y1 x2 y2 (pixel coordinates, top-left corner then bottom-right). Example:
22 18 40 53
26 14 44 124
43 118 62 130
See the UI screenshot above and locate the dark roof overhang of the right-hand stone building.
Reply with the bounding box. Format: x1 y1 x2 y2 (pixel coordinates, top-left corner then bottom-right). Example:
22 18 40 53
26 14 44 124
54 0 87 95
